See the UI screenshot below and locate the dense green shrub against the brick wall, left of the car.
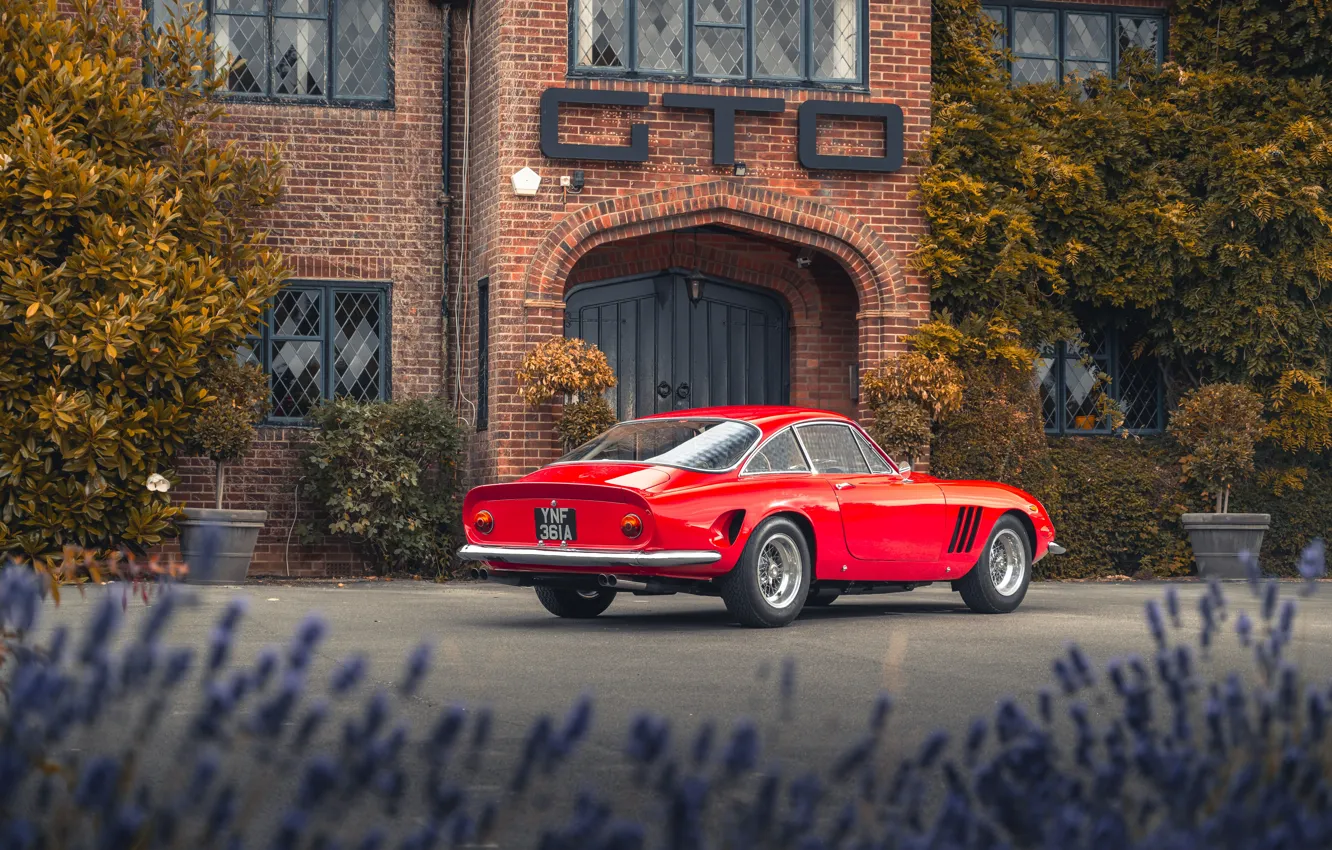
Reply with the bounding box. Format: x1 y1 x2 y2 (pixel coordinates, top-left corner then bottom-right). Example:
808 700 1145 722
301 398 464 574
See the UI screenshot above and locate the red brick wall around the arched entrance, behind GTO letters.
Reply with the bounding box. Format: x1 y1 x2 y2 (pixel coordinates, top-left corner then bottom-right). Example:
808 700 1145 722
464 0 930 480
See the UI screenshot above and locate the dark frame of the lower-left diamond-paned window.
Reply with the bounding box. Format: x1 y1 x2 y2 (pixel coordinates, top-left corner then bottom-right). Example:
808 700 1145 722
249 280 393 428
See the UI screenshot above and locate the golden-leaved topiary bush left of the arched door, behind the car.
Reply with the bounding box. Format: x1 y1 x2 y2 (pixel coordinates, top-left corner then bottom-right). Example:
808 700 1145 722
518 337 615 452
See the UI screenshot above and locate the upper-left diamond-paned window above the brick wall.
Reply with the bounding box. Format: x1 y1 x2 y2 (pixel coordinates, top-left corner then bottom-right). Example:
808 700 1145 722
152 0 392 105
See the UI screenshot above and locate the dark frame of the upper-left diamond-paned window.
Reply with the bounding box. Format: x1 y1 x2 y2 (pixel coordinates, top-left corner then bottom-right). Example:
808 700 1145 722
144 0 397 109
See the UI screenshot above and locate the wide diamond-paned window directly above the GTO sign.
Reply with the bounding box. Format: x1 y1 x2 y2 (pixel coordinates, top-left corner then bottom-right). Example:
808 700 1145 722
570 0 866 84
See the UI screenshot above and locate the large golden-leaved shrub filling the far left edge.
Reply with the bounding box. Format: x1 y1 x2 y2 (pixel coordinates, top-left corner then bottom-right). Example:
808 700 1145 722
0 0 284 570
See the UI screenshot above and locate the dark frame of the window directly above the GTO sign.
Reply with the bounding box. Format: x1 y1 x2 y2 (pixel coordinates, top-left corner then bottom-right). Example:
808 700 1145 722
567 0 870 92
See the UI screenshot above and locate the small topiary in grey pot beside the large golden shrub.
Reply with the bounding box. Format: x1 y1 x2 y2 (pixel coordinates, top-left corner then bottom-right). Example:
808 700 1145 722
178 357 269 585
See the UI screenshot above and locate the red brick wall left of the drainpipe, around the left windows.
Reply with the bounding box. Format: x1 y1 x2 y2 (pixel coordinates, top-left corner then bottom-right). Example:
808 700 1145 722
130 0 465 576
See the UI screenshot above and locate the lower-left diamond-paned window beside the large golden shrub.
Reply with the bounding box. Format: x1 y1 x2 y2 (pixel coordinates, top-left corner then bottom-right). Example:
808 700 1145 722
245 281 389 422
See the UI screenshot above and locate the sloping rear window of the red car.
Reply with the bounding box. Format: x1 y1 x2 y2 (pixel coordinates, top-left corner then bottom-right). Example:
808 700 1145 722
559 418 759 472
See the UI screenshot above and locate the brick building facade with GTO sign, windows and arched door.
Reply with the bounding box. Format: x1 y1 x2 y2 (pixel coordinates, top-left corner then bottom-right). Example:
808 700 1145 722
132 0 1166 574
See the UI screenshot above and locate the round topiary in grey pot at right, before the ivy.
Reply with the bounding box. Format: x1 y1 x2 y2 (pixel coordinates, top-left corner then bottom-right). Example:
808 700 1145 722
1169 384 1272 578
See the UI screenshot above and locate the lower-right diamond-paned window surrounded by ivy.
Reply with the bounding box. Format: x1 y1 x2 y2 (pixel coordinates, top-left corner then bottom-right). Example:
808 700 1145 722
1036 332 1166 434
